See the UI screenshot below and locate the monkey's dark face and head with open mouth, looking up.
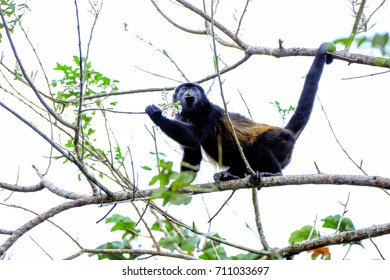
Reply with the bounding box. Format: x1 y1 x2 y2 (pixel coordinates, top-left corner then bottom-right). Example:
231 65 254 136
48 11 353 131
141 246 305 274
173 83 204 110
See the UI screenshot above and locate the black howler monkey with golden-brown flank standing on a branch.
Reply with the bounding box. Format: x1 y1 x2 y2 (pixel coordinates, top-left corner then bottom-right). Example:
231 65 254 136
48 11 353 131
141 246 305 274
145 43 333 181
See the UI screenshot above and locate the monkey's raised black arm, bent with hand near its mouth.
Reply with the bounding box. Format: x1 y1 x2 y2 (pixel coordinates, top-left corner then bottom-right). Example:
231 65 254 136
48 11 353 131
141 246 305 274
145 105 205 149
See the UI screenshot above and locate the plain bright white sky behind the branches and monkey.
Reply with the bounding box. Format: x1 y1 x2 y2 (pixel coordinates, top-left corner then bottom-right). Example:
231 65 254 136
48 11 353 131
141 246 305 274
0 0 390 259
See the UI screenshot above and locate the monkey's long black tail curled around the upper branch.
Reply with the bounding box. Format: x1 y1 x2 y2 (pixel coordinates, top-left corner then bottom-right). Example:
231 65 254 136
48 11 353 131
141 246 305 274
286 43 333 139
